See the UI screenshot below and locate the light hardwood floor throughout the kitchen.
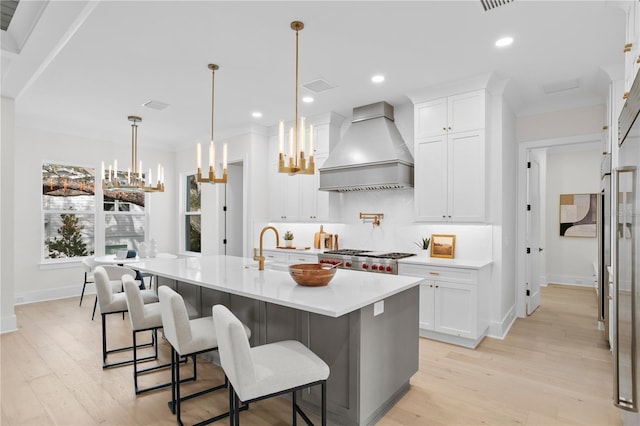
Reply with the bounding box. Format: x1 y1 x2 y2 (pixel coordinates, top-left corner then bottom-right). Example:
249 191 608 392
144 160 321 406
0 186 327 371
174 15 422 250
0 285 622 426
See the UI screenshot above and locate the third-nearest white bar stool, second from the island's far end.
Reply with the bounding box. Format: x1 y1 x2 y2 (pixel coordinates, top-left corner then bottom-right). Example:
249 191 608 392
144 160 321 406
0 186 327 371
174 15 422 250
122 275 179 395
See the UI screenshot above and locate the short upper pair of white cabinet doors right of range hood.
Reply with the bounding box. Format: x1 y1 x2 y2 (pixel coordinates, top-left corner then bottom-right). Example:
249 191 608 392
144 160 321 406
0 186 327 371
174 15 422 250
414 90 485 138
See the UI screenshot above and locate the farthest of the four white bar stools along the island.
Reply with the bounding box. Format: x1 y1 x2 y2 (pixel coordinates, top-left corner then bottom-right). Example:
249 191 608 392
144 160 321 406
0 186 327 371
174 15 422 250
94 266 158 368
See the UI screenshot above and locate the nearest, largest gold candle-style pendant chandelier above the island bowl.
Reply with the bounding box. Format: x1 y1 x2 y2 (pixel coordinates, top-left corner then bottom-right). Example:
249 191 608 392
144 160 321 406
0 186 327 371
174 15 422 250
278 21 315 175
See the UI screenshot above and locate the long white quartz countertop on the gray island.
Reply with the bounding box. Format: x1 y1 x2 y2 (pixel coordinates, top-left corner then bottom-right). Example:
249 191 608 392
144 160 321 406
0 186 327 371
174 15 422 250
127 256 422 317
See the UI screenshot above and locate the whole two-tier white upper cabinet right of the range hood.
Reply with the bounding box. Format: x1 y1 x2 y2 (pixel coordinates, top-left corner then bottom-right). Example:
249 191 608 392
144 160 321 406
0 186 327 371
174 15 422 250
414 90 486 222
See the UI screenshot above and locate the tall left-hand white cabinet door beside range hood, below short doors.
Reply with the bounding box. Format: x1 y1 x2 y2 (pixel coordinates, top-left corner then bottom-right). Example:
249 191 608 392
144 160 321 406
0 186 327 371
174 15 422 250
414 135 447 222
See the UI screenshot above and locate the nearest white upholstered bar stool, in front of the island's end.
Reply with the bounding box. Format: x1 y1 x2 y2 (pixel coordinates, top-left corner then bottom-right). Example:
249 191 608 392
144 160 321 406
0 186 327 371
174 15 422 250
213 305 330 426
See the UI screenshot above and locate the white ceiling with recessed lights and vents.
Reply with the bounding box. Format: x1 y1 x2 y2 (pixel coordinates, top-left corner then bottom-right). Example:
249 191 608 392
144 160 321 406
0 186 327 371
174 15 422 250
2 0 625 150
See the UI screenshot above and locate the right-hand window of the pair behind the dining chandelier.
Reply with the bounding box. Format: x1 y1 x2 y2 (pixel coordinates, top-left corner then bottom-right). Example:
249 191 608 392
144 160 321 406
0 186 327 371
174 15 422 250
102 184 147 254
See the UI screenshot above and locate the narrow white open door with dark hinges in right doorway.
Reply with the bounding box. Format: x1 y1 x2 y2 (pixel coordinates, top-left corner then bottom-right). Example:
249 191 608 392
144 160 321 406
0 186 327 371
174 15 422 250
526 161 542 315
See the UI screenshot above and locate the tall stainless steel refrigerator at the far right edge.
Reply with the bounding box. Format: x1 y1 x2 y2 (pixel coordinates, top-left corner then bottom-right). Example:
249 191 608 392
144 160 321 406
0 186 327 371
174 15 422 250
612 68 640 425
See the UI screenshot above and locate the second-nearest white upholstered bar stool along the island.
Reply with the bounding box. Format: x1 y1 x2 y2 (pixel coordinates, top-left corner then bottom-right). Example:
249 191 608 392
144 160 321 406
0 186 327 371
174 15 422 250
158 286 251 425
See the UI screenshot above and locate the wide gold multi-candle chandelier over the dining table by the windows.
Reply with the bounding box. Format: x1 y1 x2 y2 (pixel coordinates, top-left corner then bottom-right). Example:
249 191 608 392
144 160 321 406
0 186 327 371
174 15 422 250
102 115 164 192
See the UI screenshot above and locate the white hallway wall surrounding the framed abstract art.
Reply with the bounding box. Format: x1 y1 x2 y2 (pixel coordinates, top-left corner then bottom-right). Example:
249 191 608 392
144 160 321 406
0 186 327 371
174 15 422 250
544 150 602 285
